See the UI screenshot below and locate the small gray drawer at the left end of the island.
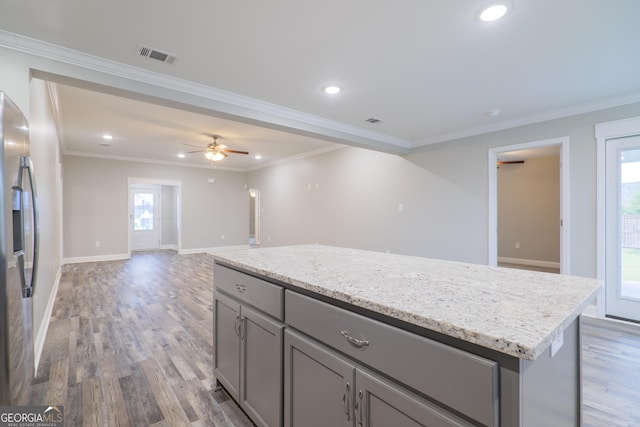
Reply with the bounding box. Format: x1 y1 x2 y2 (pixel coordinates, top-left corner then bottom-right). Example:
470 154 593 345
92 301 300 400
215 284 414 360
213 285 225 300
213 264 284 320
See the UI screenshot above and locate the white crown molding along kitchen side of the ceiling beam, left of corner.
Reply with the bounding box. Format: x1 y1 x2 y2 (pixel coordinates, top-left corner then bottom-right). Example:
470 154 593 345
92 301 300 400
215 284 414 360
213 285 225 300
0 30 412 154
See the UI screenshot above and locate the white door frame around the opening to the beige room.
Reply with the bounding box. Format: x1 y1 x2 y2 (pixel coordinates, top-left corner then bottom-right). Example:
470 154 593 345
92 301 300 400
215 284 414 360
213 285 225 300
487 136 571 274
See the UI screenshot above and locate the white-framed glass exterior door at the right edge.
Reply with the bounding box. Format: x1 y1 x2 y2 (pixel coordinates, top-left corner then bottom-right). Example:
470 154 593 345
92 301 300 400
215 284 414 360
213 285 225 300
605 136 640 321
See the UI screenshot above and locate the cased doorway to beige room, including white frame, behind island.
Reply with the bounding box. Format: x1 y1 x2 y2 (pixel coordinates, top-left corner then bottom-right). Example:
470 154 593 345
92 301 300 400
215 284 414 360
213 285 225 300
488 137 569 274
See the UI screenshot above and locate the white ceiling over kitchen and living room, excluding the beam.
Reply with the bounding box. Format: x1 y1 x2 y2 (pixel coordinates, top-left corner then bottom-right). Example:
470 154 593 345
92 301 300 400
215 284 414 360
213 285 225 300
0 0 640 169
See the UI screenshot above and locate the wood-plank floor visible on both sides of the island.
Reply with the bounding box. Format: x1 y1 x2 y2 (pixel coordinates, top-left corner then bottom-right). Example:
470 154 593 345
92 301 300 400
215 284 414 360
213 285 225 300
32 251 640 427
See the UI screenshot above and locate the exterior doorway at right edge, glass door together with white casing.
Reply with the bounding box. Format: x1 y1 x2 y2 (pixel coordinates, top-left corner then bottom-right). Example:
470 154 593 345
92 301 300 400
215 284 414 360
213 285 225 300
596 119 640 322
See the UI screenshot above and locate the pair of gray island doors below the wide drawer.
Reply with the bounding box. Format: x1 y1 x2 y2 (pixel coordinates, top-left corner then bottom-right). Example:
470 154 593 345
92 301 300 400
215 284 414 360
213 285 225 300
284 329 471 427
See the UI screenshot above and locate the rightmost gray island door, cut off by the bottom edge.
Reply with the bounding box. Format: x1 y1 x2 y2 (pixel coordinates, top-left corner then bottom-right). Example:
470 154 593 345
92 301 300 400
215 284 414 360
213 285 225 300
355 369 471 427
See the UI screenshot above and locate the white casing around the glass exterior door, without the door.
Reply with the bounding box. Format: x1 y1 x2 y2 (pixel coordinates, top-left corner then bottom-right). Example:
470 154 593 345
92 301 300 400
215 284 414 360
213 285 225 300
595 117 640 317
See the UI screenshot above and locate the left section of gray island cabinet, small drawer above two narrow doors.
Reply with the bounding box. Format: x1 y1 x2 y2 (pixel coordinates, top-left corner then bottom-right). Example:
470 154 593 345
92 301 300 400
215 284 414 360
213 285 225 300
214 265 284 427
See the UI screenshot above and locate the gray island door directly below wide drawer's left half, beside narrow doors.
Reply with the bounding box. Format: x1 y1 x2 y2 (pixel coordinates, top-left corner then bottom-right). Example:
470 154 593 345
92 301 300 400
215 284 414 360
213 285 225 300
284 329 356 427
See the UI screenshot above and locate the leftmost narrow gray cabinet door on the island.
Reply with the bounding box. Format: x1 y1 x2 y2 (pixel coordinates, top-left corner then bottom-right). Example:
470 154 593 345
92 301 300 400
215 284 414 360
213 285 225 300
213 293 240 400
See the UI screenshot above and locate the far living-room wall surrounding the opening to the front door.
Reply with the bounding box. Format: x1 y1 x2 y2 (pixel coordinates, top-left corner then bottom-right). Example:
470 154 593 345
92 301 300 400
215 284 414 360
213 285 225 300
63 156 249 260
